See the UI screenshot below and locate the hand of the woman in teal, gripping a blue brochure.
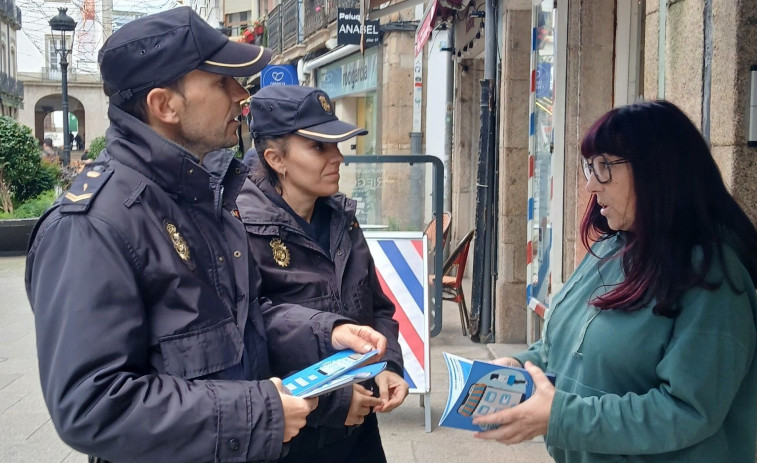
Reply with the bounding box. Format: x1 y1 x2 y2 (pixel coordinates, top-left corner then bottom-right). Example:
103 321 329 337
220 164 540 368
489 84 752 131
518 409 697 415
473 362 555 444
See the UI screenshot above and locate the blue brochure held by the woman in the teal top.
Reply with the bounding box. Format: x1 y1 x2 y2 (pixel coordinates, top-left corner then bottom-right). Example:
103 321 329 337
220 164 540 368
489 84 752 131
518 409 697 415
439 352 555 431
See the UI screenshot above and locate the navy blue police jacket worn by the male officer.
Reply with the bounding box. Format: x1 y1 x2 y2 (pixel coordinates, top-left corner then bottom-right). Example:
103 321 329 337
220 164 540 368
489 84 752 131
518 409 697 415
26 106 346 462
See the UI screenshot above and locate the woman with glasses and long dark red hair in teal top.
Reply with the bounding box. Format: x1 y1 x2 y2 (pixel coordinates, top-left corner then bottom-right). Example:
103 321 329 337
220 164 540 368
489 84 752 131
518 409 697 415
476 101 757 462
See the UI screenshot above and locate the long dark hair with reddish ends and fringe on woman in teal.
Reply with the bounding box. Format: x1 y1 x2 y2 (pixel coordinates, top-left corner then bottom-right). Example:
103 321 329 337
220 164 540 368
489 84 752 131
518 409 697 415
581 101 757 317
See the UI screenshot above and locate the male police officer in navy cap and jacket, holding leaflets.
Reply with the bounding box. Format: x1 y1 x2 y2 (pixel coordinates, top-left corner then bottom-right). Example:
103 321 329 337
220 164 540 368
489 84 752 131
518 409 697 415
26 7 386 462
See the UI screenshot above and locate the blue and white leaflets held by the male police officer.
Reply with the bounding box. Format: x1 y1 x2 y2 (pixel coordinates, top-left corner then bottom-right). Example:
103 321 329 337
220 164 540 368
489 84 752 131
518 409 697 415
282 349 386 399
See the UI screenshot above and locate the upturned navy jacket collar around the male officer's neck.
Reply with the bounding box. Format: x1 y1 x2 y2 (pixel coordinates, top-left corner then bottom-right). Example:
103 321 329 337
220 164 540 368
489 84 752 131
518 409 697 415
106 105 247 208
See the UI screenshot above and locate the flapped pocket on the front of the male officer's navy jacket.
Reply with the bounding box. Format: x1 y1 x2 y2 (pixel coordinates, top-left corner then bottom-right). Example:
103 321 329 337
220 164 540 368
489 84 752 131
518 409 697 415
160 318 244 379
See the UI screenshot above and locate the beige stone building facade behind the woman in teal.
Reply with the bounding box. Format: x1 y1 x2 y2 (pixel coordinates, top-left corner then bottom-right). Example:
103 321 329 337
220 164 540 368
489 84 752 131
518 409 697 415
442 0 757 342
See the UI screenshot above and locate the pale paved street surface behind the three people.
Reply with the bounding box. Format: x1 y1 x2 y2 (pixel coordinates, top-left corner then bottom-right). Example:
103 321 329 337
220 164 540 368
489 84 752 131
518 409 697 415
0 256 552 463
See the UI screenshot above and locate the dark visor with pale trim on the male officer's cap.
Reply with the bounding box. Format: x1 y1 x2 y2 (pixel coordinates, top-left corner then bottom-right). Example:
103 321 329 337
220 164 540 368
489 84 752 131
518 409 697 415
198 40 271 77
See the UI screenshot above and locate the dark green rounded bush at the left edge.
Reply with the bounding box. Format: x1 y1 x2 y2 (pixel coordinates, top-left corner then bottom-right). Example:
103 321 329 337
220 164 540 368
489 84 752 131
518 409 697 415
0 116 58 212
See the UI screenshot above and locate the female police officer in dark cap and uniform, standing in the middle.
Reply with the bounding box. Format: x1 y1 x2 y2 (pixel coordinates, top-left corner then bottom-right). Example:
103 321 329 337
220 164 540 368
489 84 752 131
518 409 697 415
237 86 409 463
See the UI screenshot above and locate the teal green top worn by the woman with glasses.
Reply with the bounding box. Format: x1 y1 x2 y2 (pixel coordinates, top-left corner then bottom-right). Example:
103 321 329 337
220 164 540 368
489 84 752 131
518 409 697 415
515 236 757 463
